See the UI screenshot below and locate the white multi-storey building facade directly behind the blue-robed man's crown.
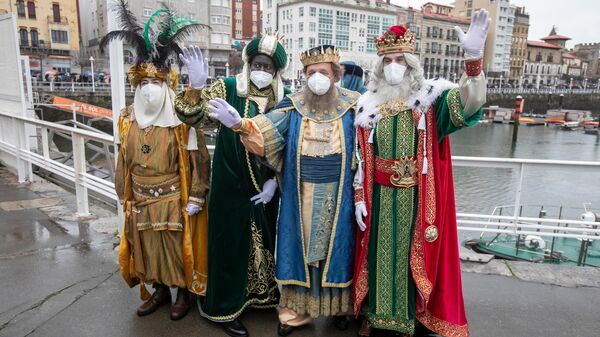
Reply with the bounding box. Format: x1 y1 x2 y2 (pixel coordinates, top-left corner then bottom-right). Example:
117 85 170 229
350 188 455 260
263 0 397 79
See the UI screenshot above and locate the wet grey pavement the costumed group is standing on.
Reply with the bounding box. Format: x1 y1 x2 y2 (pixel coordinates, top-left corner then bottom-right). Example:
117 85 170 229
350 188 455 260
0 166 600 337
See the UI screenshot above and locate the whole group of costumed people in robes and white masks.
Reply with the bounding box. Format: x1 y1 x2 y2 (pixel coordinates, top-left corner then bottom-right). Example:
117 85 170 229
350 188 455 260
102 3 489 337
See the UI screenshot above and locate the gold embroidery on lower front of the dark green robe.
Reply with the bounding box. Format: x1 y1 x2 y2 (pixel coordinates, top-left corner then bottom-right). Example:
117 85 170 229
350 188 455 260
247 220 275 295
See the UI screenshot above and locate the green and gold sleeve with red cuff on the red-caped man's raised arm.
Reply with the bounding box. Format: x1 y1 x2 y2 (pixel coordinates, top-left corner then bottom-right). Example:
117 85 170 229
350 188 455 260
434 60 486 141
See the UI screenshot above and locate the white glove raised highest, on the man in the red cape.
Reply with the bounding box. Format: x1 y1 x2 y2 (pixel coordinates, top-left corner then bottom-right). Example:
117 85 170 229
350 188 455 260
454 9 492 59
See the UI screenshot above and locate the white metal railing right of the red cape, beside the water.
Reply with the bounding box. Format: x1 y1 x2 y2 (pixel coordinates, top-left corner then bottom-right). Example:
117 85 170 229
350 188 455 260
452 156 600 240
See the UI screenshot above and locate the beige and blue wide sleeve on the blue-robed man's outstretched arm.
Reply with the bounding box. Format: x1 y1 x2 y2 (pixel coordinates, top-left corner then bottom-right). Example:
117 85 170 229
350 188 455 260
234 98 293 172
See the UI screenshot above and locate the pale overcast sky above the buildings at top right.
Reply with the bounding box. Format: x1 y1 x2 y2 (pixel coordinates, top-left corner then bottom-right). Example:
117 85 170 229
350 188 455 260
392 0 600 48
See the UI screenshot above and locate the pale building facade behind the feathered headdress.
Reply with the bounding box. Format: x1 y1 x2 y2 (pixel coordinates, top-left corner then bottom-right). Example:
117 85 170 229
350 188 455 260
79 0 230 77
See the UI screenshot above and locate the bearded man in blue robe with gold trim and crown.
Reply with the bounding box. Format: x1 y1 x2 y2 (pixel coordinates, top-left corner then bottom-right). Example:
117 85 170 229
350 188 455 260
209 45 359 336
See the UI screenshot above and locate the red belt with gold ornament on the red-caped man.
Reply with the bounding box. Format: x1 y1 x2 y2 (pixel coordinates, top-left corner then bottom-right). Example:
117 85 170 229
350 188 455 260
375 156 418 188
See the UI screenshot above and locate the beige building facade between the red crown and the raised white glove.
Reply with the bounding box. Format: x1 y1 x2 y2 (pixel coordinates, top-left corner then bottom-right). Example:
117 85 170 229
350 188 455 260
420 2 470 81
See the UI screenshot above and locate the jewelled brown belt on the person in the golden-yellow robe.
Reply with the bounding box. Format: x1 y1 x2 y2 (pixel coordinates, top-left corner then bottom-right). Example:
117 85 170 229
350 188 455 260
131 174 181 199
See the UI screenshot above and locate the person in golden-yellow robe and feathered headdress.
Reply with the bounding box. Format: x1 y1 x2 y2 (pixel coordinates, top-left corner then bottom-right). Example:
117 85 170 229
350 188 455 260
102 1 210 320
